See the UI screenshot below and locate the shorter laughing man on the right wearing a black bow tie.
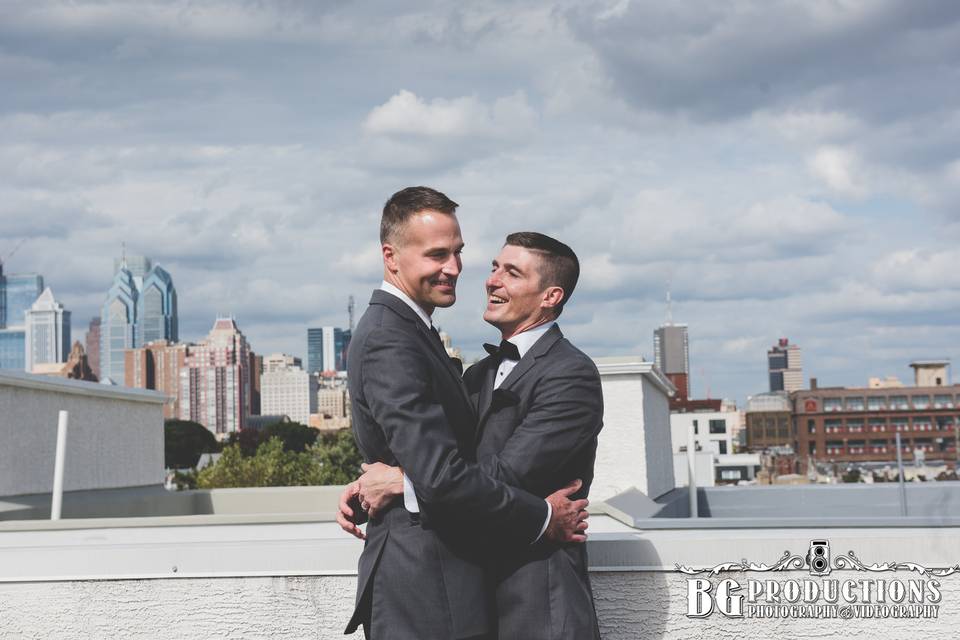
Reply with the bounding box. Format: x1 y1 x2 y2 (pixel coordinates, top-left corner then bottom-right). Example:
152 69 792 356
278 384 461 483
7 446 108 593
342 222 603 640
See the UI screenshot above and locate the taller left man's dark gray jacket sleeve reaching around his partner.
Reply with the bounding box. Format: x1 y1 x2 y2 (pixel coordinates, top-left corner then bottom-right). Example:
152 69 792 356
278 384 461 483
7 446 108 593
361 328 560 543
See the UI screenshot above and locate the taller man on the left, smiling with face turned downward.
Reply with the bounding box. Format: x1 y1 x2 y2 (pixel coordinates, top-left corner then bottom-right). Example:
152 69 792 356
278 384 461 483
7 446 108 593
337 187 587 640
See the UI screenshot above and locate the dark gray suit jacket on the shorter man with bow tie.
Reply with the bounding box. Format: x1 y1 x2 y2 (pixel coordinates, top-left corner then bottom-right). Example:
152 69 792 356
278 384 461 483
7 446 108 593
464 326 603 640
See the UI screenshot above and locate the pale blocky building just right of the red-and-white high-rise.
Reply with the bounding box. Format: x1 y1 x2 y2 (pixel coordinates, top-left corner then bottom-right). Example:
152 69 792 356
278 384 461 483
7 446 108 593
260 354 318 424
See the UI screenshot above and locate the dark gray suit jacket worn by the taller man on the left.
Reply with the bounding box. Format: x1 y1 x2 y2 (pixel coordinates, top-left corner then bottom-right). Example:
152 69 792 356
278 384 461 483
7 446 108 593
346 291 547 640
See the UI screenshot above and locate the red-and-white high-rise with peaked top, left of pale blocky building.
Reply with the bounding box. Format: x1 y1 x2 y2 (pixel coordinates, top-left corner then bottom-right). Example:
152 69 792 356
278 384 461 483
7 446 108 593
180 318 254 438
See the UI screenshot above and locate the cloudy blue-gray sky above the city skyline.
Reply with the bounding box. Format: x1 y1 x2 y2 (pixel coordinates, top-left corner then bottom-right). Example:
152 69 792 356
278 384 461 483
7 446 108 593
0 0 960 401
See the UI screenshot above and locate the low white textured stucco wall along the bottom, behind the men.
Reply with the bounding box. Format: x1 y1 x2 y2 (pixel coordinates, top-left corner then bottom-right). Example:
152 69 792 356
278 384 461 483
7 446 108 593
0 571 960 640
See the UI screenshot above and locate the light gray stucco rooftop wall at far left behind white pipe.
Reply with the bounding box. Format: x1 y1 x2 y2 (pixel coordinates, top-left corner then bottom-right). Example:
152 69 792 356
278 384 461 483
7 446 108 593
0 375 164 496
